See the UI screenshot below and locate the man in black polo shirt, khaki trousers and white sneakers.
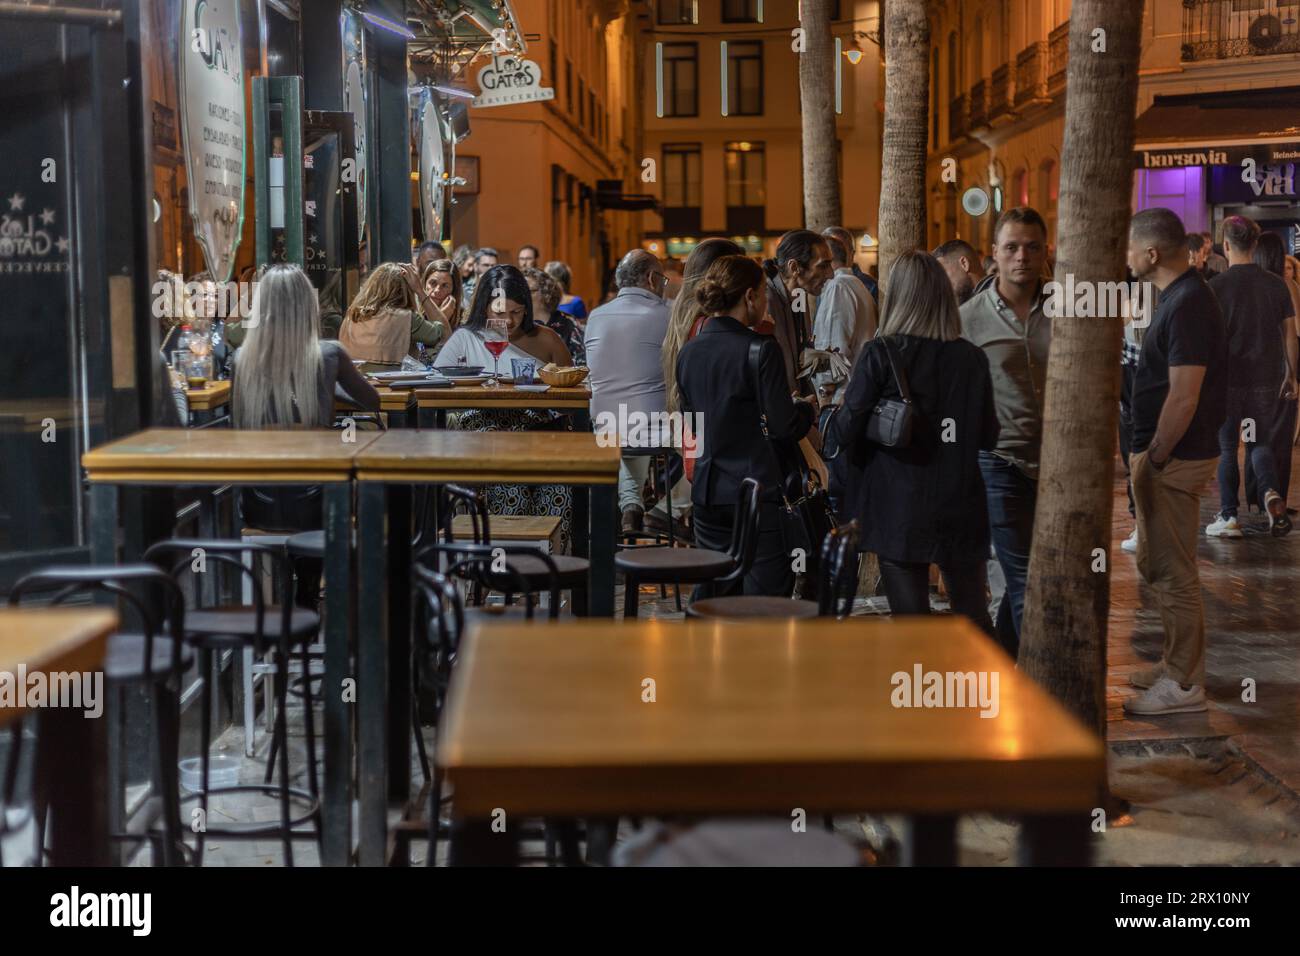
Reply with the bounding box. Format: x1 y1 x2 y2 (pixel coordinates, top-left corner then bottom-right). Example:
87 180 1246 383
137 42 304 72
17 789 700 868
1125 208 1227 715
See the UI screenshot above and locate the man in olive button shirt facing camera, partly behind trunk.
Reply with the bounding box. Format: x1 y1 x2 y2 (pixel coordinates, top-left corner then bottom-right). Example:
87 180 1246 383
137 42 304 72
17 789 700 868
961 206 1052 658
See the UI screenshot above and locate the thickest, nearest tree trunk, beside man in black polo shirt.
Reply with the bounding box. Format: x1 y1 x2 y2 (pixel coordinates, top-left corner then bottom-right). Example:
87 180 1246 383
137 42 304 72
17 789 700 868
1019 0 1144 737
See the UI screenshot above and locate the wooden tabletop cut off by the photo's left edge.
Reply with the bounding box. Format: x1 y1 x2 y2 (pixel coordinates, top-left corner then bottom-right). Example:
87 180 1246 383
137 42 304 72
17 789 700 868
0 607 117 727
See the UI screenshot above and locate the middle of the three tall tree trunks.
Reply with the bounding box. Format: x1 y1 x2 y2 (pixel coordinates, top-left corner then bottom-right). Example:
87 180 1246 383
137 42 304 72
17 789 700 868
878 0 930 285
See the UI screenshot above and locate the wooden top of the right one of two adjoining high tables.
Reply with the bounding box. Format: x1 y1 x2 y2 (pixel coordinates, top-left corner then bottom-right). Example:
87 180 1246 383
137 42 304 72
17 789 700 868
356 429 619 485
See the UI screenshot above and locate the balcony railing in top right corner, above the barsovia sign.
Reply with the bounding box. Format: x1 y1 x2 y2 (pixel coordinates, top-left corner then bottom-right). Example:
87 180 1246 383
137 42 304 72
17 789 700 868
1182 0 1300 62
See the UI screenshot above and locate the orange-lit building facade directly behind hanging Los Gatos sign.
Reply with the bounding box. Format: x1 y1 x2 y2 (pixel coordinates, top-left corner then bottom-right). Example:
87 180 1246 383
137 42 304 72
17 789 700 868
450 0 644 304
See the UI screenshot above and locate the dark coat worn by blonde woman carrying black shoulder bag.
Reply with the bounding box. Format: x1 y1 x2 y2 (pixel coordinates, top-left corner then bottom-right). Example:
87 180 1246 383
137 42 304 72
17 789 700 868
824 336 998 563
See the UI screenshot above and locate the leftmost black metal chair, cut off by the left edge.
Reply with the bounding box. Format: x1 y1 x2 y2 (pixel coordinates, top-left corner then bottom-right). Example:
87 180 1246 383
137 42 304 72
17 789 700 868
0 564 194 866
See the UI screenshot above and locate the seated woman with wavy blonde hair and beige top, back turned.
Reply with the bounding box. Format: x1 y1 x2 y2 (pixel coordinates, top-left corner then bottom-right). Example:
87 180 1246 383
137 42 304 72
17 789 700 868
338 263 447 372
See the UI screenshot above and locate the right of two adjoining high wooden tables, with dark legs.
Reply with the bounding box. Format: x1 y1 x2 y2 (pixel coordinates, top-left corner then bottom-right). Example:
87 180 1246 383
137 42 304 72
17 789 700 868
356 431 619 865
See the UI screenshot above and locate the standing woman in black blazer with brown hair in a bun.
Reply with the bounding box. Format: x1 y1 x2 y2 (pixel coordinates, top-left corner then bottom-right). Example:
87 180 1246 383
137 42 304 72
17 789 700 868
677 256 816 597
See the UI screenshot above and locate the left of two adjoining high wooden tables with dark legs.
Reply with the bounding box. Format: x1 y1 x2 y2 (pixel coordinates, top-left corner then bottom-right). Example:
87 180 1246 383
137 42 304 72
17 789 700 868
82 428 381 865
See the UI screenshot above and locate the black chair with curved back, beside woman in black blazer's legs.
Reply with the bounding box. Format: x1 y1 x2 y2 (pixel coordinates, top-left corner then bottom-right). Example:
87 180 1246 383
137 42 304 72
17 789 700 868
614 479 762 620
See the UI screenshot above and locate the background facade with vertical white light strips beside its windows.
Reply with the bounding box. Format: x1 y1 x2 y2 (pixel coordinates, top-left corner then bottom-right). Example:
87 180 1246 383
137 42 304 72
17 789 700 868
641 0 883 267
